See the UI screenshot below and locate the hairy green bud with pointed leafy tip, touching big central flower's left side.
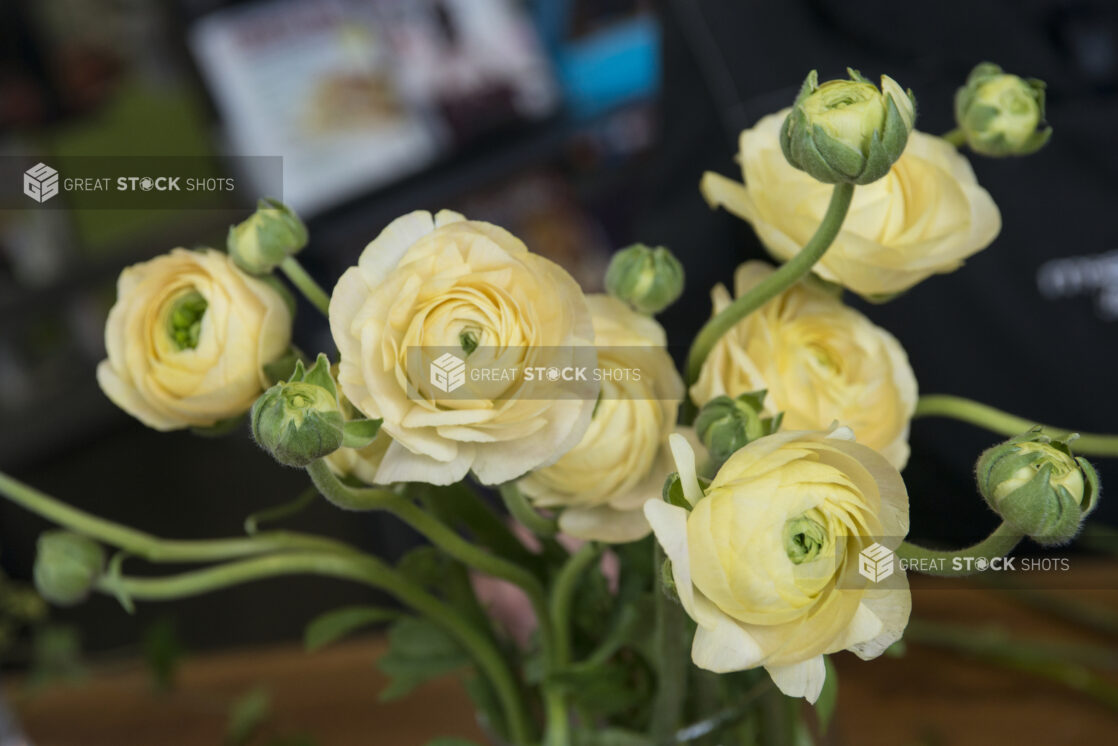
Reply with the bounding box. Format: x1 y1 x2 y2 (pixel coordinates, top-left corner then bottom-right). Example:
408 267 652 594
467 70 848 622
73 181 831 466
252 355 345 468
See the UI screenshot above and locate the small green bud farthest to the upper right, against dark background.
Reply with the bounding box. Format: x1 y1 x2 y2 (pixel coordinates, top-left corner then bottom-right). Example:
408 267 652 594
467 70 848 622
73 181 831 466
955 63 1052 158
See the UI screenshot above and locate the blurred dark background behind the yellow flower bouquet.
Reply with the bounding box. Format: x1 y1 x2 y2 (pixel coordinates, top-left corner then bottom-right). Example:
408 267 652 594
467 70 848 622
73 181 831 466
0 0 1118 662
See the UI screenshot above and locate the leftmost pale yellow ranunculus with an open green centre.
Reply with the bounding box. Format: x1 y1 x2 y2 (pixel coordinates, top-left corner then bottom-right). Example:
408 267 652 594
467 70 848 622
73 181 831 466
97 248 292 431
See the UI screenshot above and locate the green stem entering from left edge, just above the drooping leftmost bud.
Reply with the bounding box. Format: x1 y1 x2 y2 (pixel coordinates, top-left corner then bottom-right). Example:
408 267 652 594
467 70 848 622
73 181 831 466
0 472 344 563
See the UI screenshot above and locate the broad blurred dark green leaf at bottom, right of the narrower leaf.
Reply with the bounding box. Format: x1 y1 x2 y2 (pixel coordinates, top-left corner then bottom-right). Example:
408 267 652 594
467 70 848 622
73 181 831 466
377 617 470 701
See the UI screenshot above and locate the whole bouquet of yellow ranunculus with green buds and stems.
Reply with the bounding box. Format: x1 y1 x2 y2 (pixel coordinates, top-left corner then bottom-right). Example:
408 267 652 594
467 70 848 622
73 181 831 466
0 64 1104 746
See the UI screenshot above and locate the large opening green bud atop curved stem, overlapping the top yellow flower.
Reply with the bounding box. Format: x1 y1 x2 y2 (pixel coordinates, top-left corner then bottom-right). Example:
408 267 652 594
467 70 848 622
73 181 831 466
780 68 916 185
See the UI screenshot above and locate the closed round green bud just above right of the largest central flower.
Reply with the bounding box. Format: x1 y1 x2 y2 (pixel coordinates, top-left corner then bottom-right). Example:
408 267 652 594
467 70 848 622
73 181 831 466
606 244 683 314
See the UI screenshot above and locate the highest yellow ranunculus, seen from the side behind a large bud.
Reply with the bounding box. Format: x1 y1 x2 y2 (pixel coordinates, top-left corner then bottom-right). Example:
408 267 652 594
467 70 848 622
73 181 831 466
700 110 1002 296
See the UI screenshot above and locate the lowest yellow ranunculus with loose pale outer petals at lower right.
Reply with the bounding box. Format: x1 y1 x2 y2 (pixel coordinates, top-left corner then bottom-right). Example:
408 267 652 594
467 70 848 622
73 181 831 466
644 427 912 702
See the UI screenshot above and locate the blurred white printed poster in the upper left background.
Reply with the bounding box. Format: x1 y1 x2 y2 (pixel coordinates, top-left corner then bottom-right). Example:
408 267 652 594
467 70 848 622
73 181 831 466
190 0 558 215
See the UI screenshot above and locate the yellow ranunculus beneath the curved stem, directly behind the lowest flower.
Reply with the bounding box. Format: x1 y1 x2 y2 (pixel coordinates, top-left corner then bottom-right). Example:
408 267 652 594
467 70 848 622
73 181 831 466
691 262 917 469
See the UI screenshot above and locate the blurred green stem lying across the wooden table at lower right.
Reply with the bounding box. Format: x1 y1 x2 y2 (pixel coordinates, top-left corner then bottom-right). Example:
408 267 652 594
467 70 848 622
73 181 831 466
904 620 1118 710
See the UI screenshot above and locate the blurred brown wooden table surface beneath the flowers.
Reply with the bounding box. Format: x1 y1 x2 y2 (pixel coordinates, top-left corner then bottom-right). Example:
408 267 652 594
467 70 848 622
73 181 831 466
8 565 1118 746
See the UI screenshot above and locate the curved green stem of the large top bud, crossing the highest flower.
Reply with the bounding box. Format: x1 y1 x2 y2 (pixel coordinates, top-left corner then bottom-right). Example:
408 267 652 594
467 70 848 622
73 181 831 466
688 177 854 384
